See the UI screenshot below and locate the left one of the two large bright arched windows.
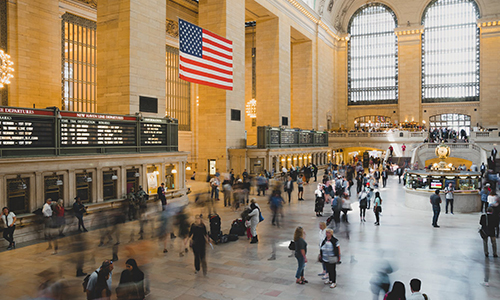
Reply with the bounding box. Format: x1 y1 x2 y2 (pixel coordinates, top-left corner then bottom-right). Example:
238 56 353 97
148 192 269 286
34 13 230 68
348 4 398 105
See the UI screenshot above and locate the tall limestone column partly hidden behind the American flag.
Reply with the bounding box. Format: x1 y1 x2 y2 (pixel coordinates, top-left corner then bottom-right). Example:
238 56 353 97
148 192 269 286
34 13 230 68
198 0 246 178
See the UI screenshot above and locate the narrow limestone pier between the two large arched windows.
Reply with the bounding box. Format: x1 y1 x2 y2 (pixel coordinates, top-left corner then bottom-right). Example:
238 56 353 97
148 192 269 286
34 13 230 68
393 26 423 122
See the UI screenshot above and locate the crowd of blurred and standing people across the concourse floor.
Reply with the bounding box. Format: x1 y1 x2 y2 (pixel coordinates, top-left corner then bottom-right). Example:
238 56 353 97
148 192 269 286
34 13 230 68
2 153 500 299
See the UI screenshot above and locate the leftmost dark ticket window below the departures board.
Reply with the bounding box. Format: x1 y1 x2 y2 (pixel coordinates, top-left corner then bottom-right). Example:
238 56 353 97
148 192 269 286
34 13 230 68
7 178 30 214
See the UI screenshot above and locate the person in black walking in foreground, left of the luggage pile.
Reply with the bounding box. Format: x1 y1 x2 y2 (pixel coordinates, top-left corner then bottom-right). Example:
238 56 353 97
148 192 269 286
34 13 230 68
189 215 209 275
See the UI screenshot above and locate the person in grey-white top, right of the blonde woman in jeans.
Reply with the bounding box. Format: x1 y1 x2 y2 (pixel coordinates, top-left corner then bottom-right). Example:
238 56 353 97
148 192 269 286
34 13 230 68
320 228 340 289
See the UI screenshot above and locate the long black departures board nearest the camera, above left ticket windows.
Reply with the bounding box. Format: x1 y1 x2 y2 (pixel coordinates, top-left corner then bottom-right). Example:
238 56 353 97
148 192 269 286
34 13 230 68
0 107 177 149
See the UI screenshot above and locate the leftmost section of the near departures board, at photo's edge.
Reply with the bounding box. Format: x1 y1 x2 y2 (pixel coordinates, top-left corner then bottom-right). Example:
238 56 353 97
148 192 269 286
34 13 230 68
0 107 55 148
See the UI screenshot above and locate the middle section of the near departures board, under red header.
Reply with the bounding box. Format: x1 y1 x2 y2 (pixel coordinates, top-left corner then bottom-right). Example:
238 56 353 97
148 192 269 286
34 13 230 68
60 112 137 147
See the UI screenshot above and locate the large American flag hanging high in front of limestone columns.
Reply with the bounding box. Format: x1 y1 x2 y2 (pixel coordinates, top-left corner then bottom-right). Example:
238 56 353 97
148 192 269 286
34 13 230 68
179 19 233 91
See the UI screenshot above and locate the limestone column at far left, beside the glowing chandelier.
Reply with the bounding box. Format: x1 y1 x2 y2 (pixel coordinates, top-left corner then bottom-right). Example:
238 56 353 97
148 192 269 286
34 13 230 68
4 0 62 108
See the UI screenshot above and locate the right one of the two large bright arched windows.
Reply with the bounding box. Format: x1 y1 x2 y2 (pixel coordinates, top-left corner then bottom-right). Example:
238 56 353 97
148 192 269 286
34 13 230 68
422 0 479 103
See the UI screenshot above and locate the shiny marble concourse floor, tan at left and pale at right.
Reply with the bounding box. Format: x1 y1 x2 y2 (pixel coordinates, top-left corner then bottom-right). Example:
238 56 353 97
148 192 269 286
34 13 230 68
0 178 500 300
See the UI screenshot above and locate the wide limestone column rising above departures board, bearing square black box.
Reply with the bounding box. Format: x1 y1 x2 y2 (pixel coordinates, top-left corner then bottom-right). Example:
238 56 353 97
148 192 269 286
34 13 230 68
97 0 166 117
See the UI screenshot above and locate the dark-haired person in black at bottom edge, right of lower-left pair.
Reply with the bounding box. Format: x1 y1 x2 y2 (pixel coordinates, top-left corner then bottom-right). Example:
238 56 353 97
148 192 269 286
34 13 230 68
116 258 146 300
